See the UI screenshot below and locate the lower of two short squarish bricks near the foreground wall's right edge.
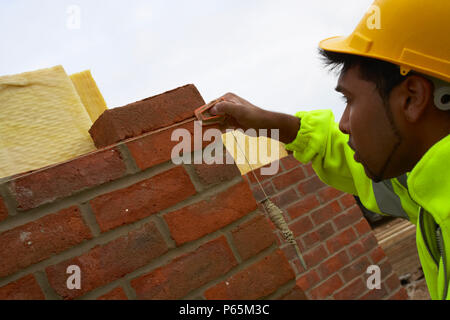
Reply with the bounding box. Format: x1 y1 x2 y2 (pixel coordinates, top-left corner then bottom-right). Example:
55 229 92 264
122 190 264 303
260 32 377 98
231 215 276 260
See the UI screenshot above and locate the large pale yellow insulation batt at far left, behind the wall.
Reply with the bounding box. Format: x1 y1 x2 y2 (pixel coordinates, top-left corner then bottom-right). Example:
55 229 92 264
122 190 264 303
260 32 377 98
0 66 96 178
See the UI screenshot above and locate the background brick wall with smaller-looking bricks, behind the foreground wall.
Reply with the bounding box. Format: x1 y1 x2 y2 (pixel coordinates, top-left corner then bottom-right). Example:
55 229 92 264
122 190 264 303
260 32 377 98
246 156 407 300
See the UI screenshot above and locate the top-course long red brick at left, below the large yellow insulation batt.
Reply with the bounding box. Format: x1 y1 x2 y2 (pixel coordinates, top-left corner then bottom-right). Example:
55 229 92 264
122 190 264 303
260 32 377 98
9 149 126 210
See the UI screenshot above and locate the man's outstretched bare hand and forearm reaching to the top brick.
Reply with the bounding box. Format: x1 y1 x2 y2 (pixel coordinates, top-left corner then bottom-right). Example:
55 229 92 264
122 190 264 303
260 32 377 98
210 93 300 143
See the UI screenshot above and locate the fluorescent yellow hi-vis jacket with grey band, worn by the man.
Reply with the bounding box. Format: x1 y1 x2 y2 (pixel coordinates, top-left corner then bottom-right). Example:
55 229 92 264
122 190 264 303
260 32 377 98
286 110 450 300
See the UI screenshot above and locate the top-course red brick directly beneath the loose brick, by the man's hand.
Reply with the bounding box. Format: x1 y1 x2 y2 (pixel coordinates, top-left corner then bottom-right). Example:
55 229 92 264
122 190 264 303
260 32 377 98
126 121 220 170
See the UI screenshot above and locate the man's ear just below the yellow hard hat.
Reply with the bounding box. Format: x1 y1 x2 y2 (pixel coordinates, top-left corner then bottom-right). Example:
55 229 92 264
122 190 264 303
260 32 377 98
394 75 434 123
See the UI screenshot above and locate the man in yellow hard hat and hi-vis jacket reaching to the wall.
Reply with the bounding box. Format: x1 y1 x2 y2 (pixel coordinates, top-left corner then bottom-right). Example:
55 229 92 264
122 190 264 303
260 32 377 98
212 0 450 299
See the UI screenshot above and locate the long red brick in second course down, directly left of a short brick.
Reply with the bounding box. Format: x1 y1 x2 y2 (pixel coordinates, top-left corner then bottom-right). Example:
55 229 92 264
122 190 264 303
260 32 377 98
90 167 196 232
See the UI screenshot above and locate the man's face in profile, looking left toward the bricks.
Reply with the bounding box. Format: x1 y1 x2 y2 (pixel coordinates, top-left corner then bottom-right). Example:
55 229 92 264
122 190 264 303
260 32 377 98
336 66 401 182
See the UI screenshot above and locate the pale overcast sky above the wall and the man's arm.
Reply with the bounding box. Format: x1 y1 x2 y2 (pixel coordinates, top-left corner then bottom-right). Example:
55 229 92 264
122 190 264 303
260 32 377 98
0 0 373 120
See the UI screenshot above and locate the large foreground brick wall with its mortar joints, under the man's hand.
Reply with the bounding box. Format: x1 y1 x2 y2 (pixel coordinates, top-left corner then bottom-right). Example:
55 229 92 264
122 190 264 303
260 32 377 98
0 85 305 300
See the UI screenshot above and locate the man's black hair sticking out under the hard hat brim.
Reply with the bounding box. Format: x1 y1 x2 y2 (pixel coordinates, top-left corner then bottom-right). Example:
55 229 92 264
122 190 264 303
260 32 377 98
319 49 407 103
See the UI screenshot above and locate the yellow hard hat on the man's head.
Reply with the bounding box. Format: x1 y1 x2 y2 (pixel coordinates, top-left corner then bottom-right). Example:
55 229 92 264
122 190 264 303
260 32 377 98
320 0 450 82
